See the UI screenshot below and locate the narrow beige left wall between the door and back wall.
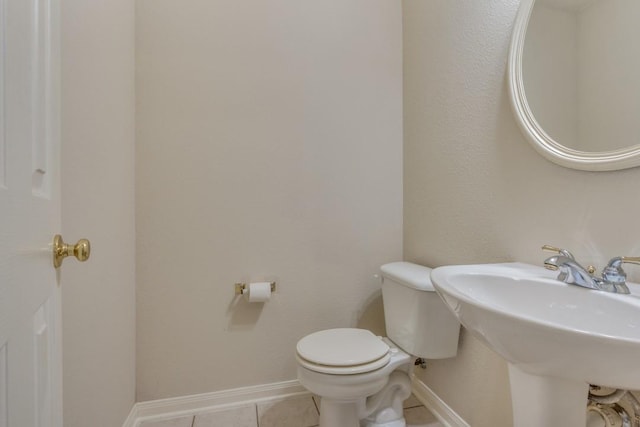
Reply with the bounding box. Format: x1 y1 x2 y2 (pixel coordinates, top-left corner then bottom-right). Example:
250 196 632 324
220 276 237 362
61 0 135 427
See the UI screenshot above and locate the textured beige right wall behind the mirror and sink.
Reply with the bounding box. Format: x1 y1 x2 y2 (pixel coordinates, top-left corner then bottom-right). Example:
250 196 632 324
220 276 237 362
403 0 640 427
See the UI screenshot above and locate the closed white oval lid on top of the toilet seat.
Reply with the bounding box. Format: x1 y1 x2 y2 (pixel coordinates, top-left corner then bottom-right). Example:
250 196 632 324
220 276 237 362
297 328 389 367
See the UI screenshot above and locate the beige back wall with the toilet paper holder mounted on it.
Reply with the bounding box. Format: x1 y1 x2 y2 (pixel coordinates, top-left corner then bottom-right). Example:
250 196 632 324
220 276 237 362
136 0 402 400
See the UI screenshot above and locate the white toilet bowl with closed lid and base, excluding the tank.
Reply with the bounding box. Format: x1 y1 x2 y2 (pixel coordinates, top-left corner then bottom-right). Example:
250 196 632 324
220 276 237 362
296 328 411 427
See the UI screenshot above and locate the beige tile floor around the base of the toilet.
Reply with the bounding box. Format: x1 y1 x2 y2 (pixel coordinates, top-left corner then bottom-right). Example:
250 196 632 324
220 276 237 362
139 396 442 427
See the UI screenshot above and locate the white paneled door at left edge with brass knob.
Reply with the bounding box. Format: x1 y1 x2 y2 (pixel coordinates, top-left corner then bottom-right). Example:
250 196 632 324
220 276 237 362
0 0 62 427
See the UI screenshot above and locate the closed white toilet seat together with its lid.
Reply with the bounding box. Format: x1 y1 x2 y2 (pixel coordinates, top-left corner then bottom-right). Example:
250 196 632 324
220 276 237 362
296 328 391 375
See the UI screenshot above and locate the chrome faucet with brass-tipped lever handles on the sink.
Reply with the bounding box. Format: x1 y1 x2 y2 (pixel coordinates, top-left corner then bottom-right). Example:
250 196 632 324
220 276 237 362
542 245 640 294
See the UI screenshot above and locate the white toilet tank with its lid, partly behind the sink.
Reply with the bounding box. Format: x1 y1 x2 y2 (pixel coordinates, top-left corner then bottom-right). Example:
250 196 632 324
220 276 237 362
380 262 460 359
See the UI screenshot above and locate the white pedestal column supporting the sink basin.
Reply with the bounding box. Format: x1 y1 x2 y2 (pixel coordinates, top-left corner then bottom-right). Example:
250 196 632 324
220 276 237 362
509 363 589 427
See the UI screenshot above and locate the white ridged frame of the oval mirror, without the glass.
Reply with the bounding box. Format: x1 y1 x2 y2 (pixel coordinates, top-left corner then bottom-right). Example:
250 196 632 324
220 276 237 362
508 0 640 171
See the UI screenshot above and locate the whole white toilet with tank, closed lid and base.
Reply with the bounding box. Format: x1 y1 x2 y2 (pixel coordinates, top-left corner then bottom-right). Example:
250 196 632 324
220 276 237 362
296 262 460 427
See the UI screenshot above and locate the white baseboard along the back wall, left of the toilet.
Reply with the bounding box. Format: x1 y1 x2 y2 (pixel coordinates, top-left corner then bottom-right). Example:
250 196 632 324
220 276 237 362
122 380 310 427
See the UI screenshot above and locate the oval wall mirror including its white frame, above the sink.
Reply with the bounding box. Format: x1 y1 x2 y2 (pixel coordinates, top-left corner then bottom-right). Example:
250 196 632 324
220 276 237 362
509 0 640 171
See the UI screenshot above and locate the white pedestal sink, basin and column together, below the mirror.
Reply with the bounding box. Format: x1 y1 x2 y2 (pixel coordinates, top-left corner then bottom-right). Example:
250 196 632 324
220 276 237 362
431 263 640 427
